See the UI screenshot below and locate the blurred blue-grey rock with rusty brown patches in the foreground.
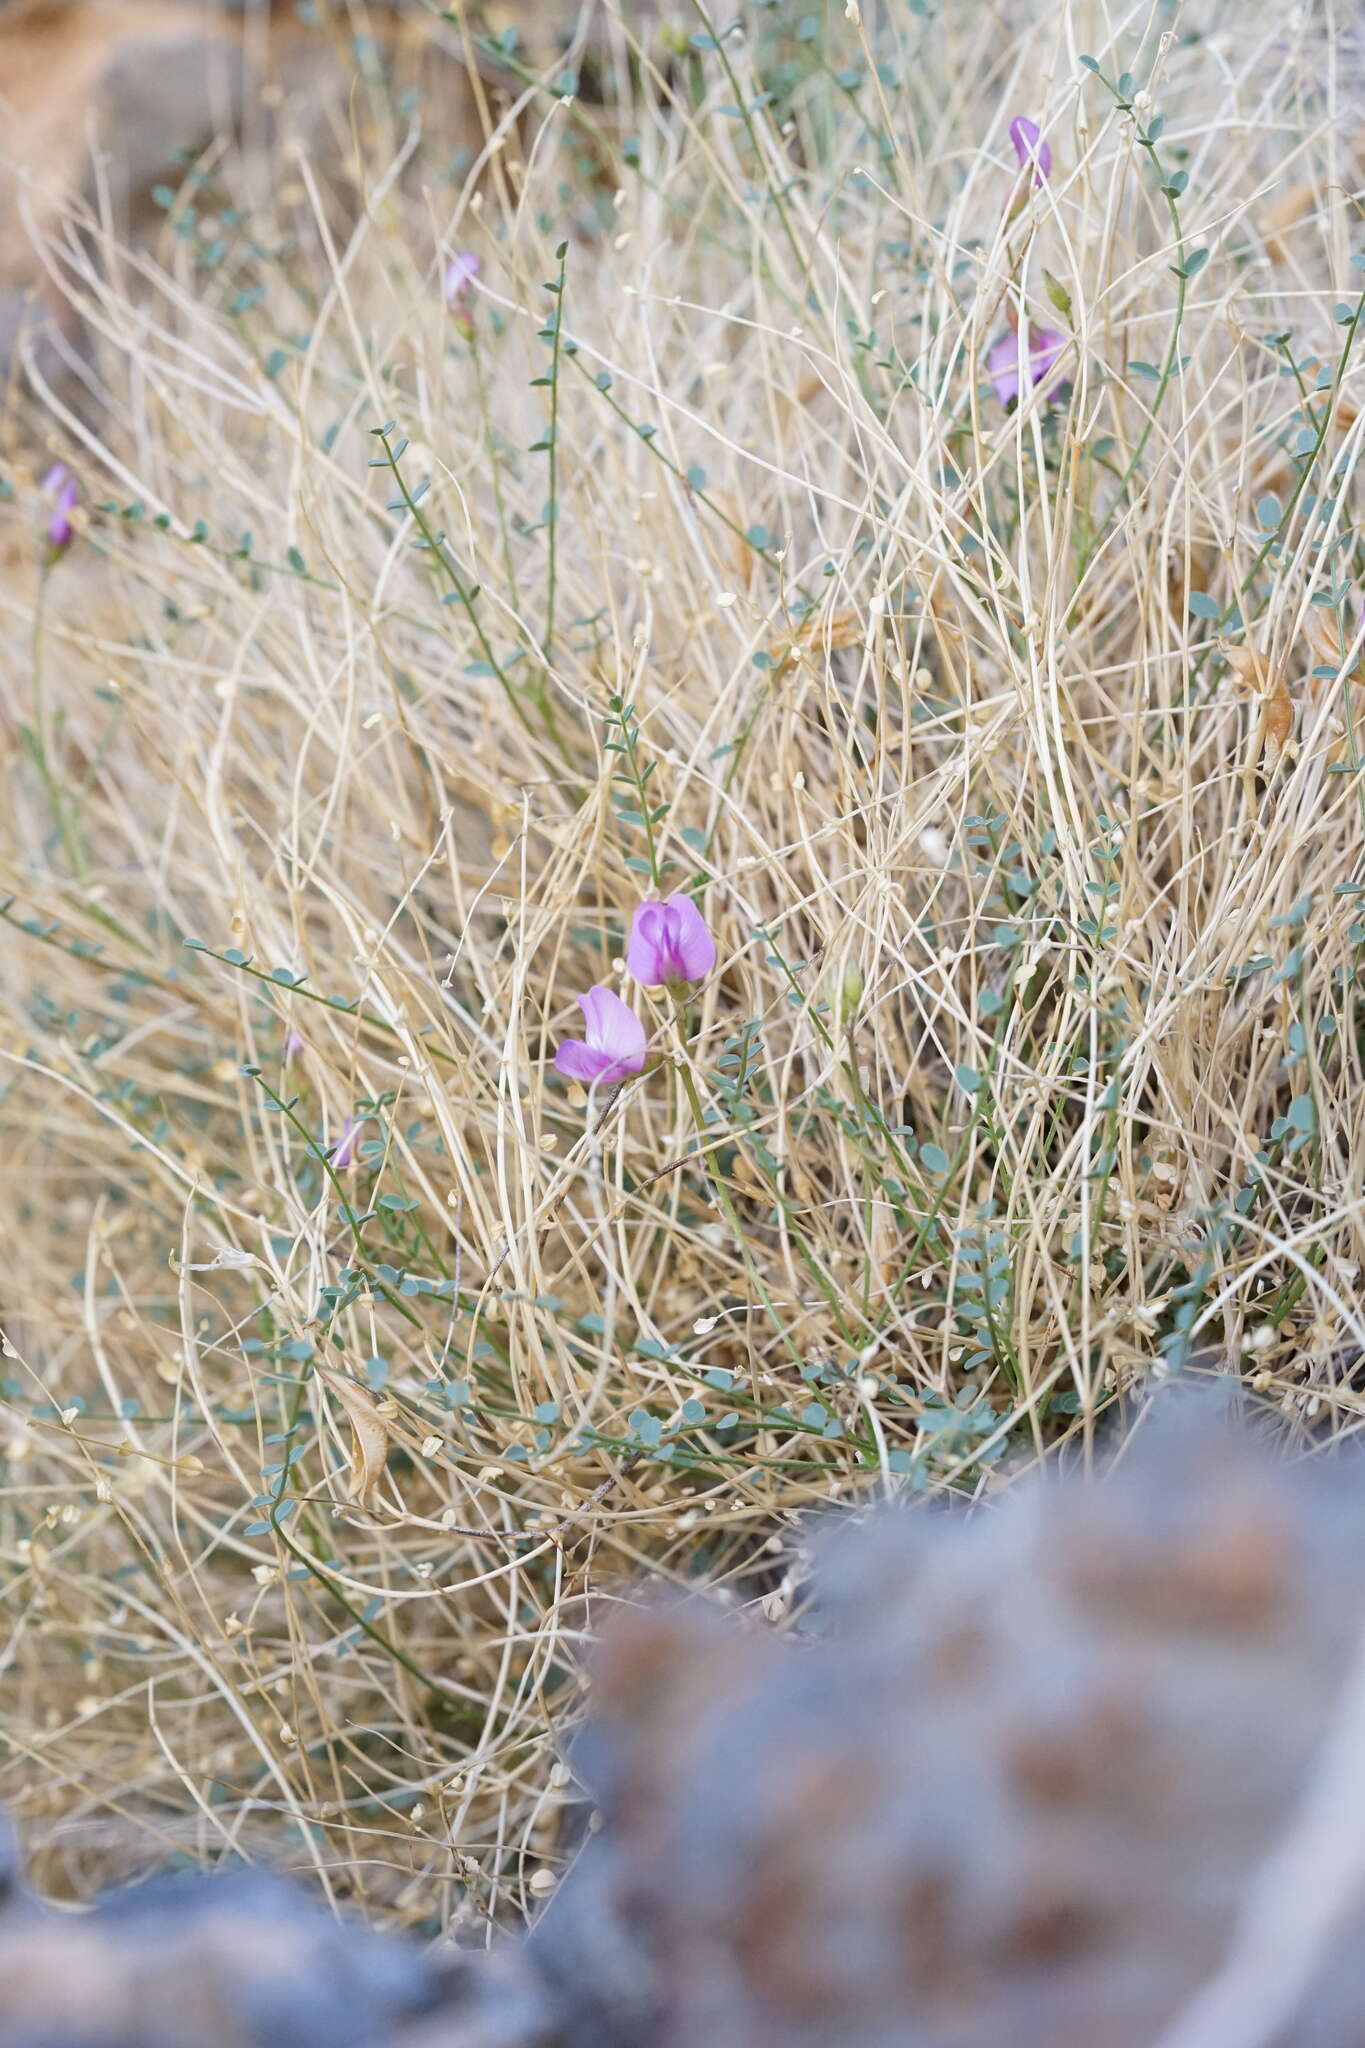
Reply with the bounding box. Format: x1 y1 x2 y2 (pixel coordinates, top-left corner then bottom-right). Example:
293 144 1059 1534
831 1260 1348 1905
0 1399 1365 2048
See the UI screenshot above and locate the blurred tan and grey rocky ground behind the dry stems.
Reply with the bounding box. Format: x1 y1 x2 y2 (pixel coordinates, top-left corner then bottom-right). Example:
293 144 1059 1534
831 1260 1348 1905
0 0 655 397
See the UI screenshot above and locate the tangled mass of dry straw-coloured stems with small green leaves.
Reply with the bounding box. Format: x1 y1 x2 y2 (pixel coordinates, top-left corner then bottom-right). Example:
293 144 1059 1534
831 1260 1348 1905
0 0 1365 1925
